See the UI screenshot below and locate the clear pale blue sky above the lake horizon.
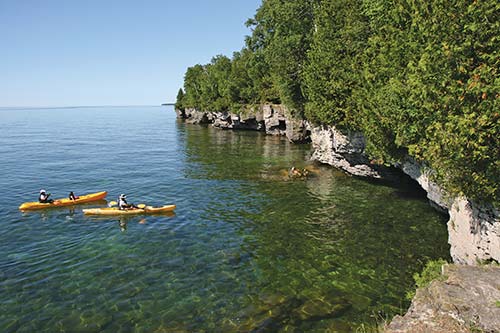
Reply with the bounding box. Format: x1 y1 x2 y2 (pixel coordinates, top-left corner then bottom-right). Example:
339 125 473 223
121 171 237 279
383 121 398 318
0 0 261 106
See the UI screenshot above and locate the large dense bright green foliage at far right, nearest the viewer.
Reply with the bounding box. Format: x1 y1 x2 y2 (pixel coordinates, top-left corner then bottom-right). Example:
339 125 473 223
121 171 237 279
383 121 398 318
354 0 500 202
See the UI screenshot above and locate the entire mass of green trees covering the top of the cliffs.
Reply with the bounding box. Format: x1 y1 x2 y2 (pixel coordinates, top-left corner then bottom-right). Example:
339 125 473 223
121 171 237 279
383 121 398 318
177 0 500 202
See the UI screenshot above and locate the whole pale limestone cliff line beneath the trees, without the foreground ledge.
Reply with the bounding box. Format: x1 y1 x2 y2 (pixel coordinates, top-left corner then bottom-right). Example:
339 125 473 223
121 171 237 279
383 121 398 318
176 104 500 265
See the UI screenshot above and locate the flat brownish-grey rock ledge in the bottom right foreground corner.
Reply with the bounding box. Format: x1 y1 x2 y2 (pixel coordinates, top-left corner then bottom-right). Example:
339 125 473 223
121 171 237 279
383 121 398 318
385 265 500 333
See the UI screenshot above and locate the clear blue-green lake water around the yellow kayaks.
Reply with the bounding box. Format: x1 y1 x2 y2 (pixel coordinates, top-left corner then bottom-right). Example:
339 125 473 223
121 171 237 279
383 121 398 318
0 107 449 332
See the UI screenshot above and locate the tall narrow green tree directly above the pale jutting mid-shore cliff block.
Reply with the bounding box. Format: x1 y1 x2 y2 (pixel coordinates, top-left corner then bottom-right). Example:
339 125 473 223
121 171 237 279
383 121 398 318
304 0 368 127
